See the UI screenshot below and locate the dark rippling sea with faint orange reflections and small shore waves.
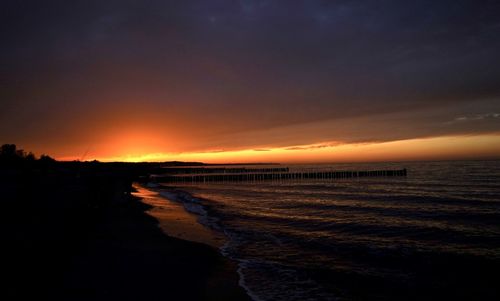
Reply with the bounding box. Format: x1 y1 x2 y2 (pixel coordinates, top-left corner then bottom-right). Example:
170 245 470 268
157 161 500 301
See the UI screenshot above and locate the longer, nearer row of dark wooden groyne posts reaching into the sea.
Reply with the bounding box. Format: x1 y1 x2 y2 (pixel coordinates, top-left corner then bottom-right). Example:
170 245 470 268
154 169 407 182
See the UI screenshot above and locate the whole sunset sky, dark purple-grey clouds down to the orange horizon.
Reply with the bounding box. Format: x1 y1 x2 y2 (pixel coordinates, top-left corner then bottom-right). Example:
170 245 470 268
0 0 500 162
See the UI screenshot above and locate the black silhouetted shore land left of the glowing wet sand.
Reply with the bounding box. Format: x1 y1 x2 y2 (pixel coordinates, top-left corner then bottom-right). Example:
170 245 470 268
0 161 249 300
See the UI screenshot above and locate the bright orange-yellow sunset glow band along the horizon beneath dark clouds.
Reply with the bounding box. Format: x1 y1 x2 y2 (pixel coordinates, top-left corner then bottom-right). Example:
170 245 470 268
58 133 500 163
